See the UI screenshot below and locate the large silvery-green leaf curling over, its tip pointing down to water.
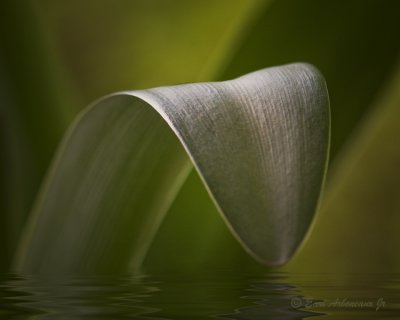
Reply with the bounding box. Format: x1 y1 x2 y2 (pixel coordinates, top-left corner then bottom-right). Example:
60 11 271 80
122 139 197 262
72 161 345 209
16 64 329 273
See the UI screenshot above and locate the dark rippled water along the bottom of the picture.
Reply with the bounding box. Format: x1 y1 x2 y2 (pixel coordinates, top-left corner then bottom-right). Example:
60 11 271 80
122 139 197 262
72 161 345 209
0 272 400 320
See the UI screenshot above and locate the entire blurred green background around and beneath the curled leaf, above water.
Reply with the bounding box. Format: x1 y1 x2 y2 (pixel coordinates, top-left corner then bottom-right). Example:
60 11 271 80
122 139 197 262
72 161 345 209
0 0 400 272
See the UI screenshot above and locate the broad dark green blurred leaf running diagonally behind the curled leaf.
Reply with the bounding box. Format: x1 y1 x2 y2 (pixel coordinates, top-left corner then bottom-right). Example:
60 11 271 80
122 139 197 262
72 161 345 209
145 0 400 271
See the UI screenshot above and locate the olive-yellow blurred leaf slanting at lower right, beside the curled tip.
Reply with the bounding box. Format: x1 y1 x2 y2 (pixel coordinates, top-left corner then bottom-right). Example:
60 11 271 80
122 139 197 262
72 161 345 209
287 60 400 274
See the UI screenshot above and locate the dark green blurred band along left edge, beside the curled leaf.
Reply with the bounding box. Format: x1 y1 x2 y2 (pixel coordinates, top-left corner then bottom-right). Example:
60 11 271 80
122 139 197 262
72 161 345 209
0 0 79 270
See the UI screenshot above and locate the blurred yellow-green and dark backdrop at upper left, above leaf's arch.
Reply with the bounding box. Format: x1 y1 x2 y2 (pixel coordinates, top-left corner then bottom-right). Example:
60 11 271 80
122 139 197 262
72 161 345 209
0 0 268 270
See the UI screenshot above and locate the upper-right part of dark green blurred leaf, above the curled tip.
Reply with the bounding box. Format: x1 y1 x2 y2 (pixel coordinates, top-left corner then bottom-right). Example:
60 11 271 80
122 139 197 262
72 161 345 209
223 0 400 159
